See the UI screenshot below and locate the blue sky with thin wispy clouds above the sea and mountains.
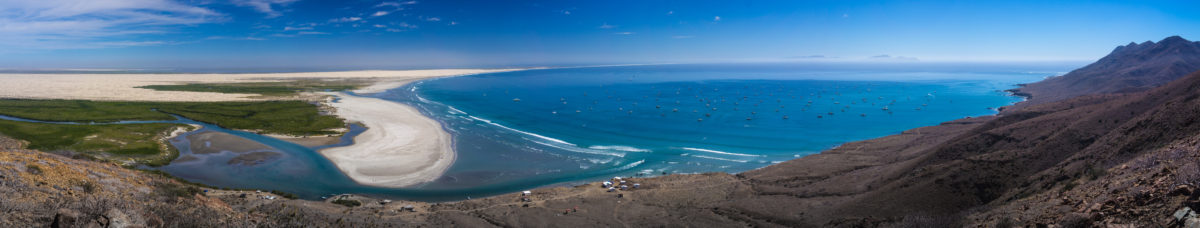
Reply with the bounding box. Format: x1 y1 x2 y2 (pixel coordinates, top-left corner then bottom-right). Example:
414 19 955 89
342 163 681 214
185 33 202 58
0 0 1200 68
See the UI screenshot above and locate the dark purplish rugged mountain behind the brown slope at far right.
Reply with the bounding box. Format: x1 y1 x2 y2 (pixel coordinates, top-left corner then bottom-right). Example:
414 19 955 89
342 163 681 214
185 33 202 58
1010 36 1200 107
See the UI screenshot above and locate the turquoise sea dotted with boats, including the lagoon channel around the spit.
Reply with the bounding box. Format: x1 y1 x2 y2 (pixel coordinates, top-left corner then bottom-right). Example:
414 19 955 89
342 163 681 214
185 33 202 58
0 65 1067 202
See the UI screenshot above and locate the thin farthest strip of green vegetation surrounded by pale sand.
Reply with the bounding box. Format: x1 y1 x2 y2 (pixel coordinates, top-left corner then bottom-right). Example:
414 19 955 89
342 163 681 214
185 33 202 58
139 79 366 96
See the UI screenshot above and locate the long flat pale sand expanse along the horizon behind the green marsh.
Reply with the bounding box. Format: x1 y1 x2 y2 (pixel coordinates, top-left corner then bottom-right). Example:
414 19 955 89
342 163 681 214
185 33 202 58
0 68 515 101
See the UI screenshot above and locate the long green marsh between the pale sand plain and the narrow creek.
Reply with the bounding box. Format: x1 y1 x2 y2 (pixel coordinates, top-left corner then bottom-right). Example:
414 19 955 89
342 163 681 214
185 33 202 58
0 100 346 135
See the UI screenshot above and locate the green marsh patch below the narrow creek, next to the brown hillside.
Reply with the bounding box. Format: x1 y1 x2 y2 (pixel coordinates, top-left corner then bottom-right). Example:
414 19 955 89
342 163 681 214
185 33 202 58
0 120 186 166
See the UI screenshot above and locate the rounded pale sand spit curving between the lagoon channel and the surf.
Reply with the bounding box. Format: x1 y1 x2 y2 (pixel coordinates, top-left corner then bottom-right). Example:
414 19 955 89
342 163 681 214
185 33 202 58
320 92 455 187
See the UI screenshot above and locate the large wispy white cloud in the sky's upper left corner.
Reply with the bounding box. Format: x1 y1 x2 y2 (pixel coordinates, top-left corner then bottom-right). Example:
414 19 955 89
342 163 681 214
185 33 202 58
0 0 224 50
